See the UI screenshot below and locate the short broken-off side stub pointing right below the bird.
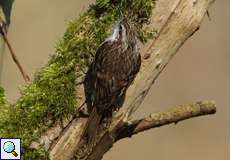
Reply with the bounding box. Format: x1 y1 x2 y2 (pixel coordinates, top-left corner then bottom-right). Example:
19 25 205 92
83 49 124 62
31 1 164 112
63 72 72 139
116 101 216 140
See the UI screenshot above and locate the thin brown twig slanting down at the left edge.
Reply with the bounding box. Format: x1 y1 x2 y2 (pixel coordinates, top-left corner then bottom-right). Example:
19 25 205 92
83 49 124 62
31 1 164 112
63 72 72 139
0 21 30 83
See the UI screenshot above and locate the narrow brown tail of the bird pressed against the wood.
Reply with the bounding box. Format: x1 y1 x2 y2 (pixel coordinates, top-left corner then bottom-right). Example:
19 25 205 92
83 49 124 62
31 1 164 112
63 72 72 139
83 107 101 144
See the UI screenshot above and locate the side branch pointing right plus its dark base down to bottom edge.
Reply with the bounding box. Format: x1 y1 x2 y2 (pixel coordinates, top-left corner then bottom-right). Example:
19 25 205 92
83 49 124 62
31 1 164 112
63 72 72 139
84 101 216 160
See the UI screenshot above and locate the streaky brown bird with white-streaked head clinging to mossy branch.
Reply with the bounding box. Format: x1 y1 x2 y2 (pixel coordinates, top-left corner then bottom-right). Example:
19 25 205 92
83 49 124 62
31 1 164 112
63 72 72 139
83 16 141 142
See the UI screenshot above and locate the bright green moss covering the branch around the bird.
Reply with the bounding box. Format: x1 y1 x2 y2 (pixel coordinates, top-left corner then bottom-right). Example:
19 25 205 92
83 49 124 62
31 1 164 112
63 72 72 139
0 0 154 159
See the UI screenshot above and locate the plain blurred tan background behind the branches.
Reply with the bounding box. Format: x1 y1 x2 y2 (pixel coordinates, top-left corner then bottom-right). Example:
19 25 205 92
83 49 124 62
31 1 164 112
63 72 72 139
0 0 230 160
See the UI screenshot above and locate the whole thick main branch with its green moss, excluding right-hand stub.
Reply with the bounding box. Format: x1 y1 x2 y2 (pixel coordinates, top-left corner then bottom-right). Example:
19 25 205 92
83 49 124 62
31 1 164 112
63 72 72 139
0 0 217 160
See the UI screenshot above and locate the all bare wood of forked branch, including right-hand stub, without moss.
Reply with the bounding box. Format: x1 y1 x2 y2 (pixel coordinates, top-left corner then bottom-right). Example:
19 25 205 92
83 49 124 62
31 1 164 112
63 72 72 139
48 0 216 160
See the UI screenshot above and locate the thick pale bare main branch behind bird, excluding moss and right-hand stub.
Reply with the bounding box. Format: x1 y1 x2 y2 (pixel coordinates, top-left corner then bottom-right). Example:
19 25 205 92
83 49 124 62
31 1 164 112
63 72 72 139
50 0 216 160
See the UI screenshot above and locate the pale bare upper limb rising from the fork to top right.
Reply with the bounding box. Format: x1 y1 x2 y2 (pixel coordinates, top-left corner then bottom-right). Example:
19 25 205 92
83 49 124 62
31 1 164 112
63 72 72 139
125 0 214 115
